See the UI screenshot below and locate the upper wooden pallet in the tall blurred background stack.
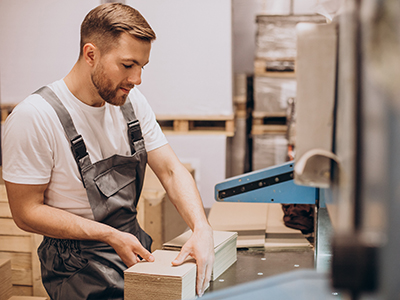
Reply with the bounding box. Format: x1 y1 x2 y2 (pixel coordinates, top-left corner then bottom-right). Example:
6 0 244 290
254 58 296 78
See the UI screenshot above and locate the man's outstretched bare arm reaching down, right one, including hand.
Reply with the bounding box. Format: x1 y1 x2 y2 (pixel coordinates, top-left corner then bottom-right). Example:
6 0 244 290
148 144 214 296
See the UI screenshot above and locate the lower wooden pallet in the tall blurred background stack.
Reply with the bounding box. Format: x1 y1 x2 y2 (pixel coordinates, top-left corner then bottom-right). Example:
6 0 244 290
251 111 287 135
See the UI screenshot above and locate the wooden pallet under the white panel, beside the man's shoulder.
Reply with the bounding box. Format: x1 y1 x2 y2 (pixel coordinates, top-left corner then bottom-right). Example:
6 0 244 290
156 114 235 136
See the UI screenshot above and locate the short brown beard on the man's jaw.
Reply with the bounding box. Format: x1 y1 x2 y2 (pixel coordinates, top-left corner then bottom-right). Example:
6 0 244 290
91 63 133 106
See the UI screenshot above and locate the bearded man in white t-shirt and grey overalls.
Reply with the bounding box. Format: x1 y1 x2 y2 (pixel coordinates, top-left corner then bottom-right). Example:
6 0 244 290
3 3 214 299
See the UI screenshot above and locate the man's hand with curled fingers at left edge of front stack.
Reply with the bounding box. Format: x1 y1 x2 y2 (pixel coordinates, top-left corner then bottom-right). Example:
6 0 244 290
107 231 154 268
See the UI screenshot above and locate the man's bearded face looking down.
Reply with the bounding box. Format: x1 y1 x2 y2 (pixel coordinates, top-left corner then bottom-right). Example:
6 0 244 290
91 33 151 106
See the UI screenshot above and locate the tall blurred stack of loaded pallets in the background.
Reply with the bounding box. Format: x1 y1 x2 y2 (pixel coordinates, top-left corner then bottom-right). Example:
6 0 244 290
252 15 326 170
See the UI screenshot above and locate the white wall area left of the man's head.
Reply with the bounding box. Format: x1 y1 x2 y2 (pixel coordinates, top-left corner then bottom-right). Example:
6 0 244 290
0 0 100 103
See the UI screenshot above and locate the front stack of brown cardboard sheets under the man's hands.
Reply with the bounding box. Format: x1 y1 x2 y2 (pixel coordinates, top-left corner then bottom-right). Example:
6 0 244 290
124 250 196 300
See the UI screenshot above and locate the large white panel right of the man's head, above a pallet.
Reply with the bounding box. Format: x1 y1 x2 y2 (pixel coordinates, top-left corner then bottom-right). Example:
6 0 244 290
126 0 232 115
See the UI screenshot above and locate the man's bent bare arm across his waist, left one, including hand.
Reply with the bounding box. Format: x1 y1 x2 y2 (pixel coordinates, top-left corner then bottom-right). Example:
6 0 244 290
6 182 154 267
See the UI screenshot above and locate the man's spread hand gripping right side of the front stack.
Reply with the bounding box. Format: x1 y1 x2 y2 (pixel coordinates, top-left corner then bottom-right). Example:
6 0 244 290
172 226 215 297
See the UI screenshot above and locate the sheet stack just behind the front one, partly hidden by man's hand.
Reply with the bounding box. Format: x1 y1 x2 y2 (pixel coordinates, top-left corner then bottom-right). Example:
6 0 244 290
163 230 237 281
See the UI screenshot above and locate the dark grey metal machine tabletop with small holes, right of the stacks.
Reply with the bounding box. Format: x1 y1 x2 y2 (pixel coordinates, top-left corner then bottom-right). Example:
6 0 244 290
206 248 314 292
